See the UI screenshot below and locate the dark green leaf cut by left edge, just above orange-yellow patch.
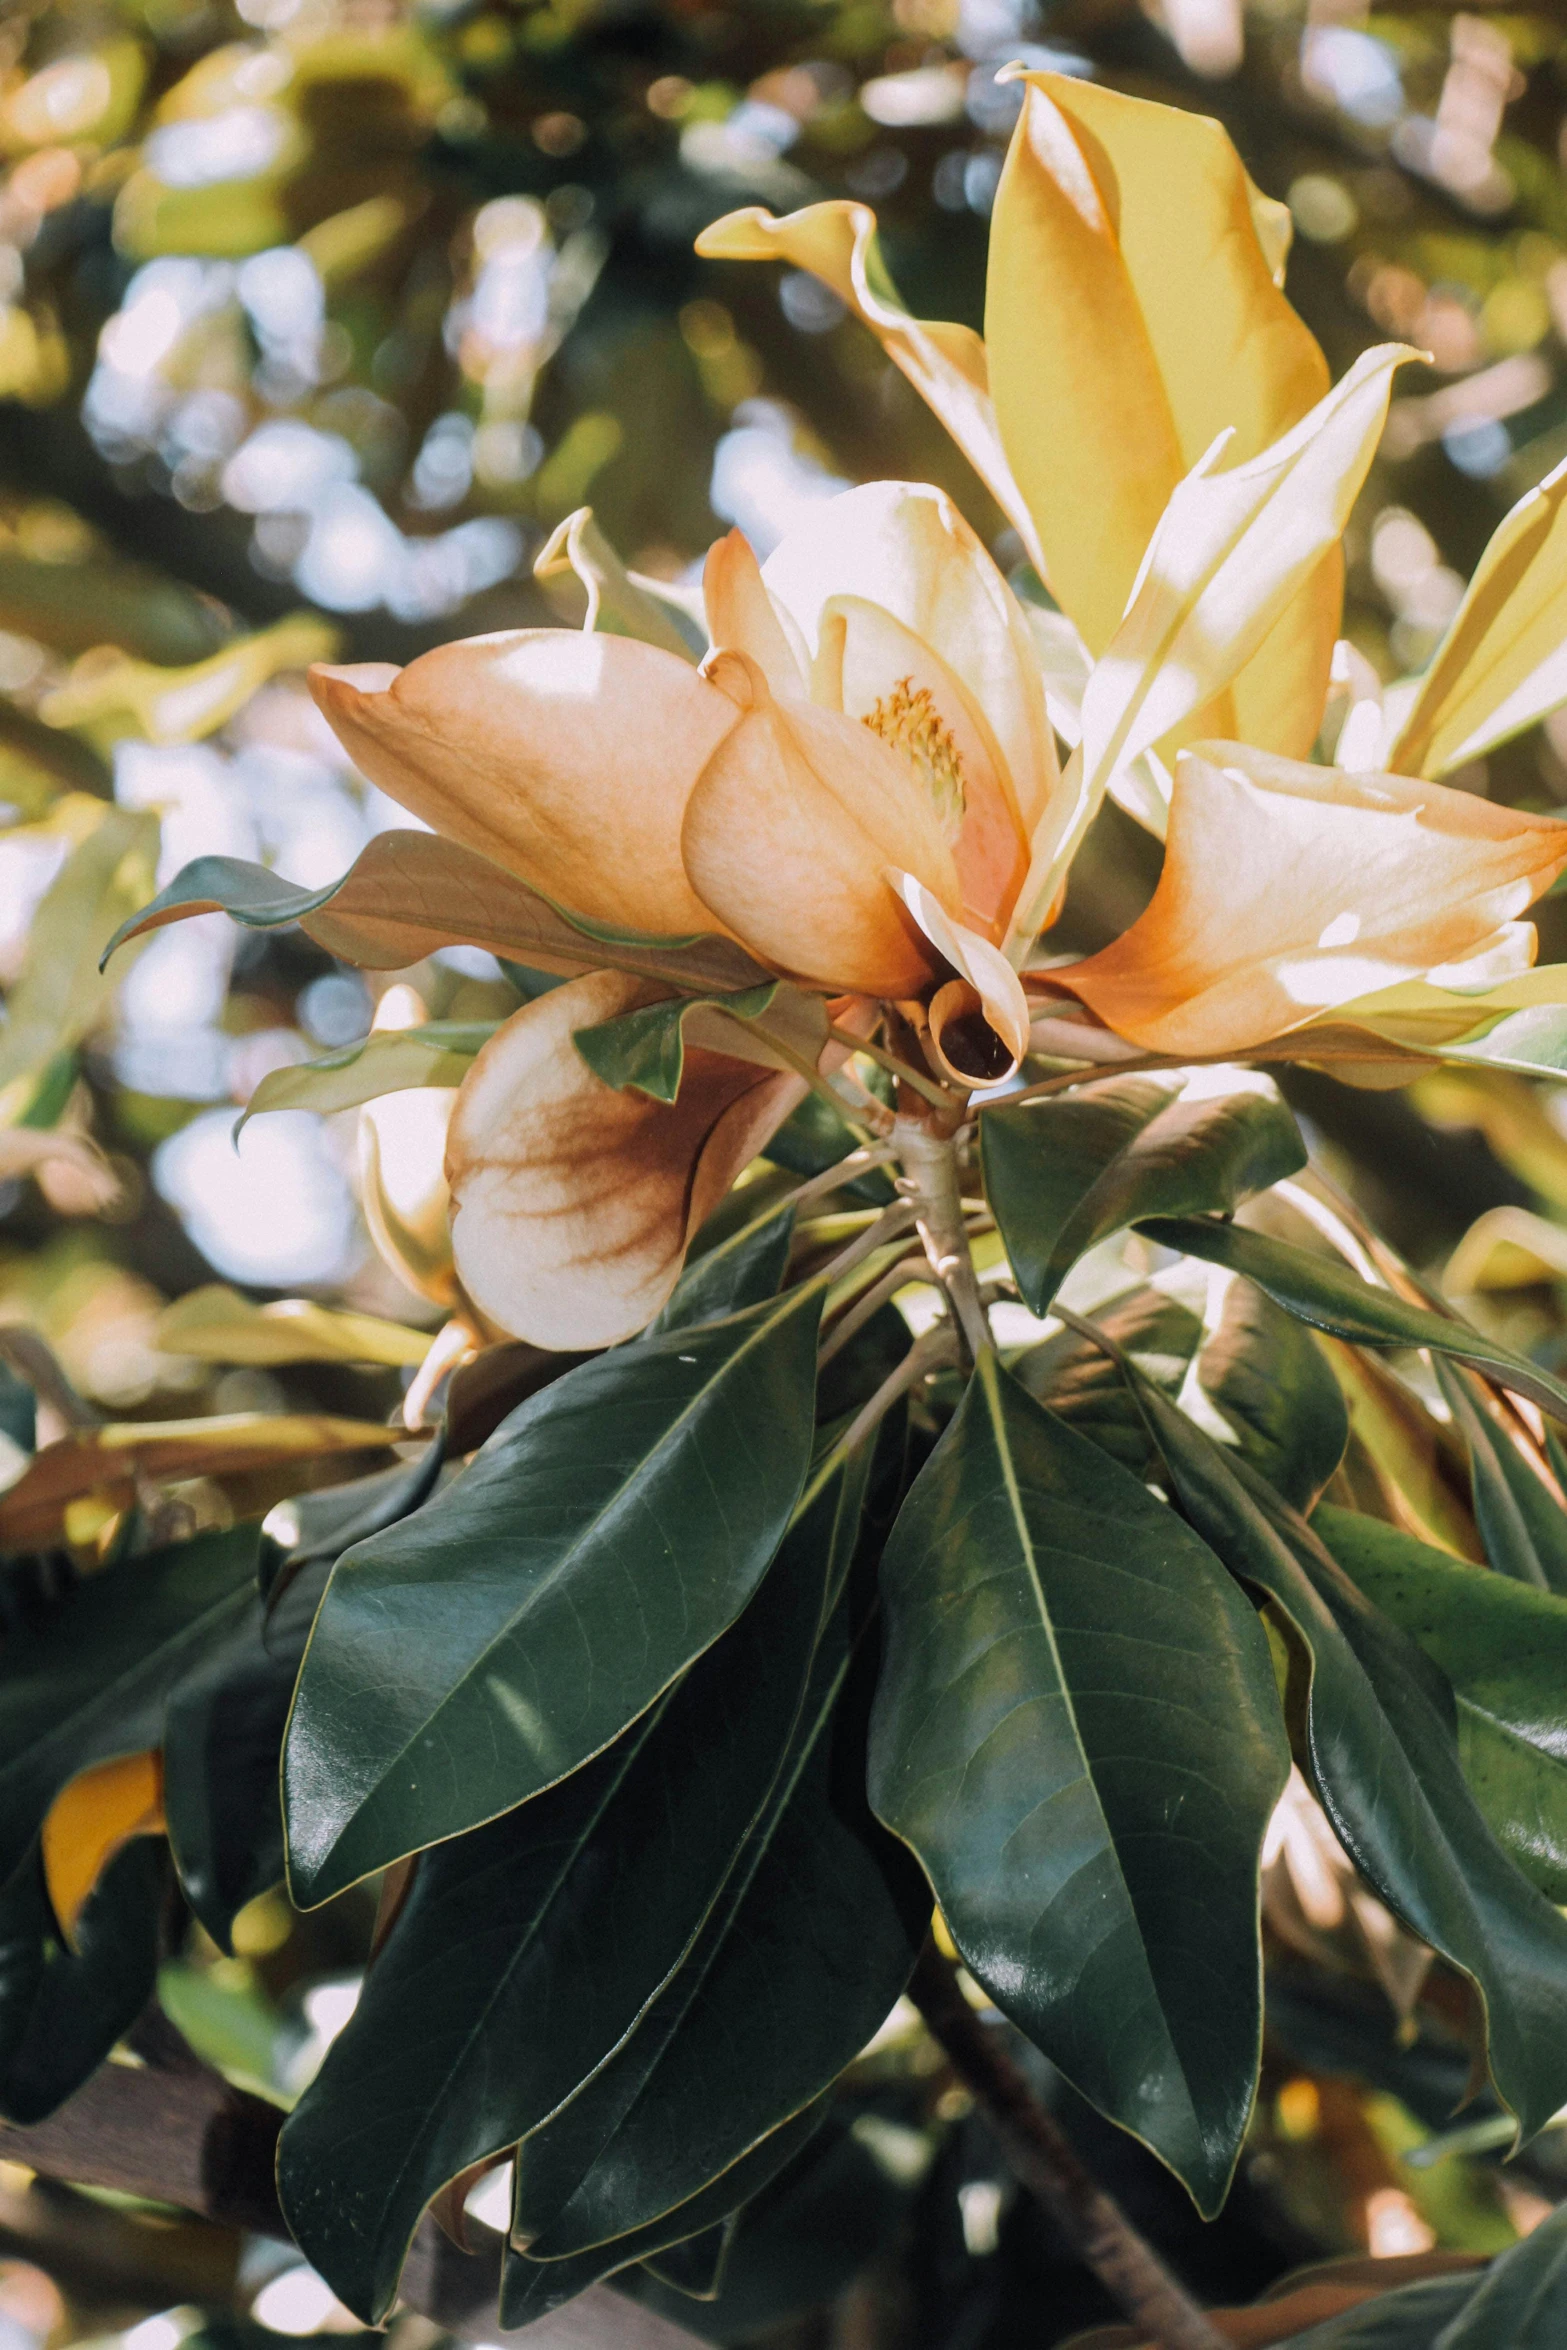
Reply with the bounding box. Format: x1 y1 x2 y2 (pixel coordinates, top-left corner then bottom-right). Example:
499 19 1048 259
0 1525 261 1882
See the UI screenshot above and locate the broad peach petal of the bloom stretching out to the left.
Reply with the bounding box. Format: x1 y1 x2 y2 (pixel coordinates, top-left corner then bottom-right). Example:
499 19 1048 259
310 627 735 938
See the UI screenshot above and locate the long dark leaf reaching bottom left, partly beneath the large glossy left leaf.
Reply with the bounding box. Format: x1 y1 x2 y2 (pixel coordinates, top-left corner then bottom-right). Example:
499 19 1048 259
277 1459 867 2322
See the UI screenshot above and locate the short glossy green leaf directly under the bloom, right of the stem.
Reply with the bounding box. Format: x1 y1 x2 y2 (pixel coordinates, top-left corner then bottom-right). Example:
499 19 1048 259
980 1076 1306 1314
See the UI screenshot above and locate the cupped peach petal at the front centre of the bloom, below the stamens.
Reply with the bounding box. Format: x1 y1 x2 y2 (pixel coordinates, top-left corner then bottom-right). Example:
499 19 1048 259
681 653 959 999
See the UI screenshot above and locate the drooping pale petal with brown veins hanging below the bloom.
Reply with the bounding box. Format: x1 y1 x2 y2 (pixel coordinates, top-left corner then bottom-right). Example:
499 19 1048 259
446 971 806 1349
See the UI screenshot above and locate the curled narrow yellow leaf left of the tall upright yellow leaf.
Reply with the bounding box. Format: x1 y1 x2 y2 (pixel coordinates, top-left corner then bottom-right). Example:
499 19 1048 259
695 197 1043 573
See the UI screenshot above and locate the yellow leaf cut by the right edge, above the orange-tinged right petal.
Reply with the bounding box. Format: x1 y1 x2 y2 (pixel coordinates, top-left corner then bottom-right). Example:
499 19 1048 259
1388 463 1567 776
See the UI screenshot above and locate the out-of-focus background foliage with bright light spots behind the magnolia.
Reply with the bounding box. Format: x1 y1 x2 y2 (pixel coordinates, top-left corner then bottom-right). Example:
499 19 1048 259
0 0 1567 2350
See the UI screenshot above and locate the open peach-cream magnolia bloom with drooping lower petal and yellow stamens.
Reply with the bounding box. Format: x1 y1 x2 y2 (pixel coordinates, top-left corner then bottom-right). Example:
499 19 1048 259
312 345 1403 1347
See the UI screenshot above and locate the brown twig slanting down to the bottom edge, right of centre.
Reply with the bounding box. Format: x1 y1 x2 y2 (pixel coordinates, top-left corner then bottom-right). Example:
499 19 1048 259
909 1941 1226 2350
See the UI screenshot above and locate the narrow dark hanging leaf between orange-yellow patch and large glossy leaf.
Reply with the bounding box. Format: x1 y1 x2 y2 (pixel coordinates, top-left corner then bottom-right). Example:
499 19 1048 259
164 1560 331 1951
